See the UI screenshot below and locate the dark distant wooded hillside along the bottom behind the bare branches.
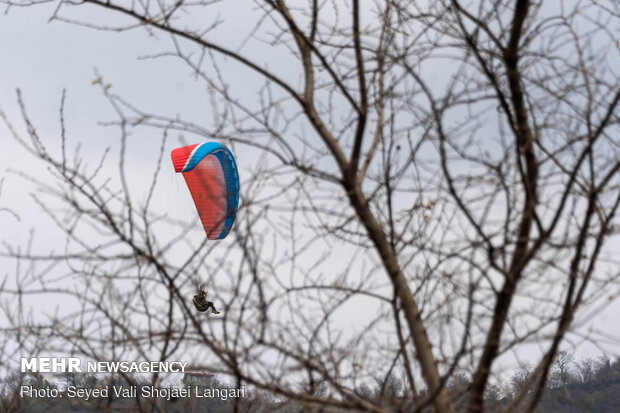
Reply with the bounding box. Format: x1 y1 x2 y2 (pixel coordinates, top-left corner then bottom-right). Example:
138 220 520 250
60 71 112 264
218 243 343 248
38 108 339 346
0 352 620 413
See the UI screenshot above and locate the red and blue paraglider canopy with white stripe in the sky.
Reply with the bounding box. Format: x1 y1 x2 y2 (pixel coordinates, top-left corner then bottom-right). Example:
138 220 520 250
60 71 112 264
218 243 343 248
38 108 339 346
171 142 239 239
